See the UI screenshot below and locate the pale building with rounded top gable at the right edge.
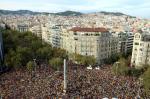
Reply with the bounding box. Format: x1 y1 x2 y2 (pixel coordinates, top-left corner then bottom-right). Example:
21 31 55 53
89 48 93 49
131 33 150 67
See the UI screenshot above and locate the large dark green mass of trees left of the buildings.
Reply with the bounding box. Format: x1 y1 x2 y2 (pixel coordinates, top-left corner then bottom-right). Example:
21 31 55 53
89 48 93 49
2 29 67 68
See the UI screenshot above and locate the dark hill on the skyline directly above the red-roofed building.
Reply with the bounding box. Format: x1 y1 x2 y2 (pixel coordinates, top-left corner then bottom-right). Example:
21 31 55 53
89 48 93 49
54 11 82 16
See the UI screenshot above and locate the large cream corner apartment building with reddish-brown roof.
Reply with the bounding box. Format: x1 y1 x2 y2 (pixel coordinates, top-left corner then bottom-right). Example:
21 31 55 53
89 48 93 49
61 27 118 64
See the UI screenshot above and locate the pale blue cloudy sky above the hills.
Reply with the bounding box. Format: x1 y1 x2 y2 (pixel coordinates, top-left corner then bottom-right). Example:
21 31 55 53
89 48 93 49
0 0 150 18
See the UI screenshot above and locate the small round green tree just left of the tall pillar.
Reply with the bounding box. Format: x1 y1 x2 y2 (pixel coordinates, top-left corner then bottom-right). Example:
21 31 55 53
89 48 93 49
49 58 63 70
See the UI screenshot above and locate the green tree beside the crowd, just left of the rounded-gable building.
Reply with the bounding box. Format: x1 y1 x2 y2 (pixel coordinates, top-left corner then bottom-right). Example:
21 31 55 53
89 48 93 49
112 58 128 75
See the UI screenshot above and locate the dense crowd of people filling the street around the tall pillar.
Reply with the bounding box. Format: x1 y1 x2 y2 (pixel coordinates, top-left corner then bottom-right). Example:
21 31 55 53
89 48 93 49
0 65 150 99
